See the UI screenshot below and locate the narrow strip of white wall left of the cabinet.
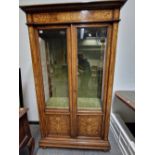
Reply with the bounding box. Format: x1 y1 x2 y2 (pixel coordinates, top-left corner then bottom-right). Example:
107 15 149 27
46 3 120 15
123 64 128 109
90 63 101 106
19 10 38 121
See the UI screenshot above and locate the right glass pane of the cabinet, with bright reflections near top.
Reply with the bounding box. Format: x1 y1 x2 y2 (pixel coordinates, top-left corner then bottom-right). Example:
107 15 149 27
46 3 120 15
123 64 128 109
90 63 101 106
77 27 107 110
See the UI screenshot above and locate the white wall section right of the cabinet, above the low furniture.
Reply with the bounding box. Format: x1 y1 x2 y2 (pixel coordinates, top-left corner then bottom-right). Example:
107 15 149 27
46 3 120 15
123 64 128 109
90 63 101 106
113 0 135 91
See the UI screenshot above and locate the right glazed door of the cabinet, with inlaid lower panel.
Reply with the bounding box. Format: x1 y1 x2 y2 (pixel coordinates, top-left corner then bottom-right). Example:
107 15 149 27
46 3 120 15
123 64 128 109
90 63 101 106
71 24 110 139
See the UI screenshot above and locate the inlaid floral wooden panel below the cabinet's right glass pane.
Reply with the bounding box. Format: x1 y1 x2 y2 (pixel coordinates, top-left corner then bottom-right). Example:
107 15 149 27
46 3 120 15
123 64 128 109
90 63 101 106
78 115 102 137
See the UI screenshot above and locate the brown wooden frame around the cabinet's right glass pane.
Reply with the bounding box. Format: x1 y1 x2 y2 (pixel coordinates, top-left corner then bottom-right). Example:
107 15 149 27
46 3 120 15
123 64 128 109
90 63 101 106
71 23 112 140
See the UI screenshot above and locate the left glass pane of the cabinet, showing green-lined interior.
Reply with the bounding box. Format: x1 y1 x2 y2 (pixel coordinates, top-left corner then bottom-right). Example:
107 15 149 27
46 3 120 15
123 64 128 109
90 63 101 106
39 29 69 109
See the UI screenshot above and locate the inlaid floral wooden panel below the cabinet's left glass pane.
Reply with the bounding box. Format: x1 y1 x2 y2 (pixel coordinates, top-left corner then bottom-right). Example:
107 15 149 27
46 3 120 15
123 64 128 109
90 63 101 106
47 114 70 136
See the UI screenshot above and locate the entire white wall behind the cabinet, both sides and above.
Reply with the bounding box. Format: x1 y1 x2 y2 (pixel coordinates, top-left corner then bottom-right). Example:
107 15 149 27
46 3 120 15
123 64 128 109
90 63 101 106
19 0 135 121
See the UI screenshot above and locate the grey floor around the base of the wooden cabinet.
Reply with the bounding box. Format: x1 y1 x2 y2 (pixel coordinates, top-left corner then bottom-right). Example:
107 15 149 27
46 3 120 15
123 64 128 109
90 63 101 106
30 125 122 155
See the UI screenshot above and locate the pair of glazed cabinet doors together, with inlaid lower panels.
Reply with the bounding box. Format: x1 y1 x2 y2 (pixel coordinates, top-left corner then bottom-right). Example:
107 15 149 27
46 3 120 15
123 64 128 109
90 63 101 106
38 24 111 139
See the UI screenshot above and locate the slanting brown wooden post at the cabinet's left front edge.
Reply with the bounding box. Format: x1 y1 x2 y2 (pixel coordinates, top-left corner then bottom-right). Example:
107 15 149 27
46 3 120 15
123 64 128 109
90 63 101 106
28 19 46 138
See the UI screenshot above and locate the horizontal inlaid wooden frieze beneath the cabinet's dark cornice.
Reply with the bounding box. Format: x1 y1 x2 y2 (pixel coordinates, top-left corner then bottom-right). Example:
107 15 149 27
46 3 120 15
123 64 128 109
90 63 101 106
32 10 113 24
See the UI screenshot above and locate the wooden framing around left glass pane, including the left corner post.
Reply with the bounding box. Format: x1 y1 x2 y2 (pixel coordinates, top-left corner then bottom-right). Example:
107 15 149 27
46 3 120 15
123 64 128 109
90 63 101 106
28 24 73 138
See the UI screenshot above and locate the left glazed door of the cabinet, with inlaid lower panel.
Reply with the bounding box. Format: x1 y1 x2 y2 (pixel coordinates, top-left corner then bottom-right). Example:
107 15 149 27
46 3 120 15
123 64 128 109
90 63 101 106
38 26 72 137
